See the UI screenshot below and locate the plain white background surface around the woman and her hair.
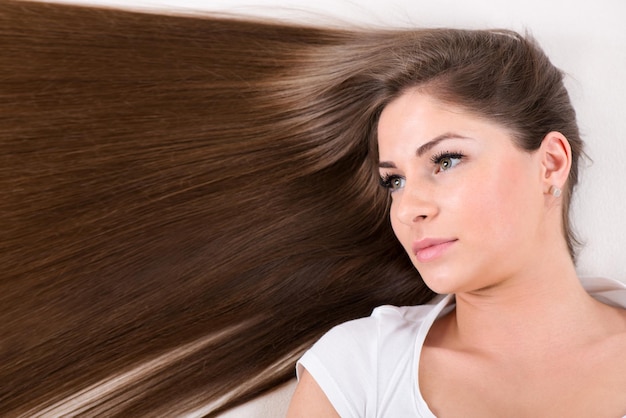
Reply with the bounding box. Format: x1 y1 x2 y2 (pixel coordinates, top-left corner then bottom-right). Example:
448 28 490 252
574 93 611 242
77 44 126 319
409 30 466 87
31 0 626 417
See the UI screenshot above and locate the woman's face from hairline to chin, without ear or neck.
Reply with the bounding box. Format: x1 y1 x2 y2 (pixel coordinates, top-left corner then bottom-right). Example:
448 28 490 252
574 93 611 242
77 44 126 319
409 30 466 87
378 90 546 293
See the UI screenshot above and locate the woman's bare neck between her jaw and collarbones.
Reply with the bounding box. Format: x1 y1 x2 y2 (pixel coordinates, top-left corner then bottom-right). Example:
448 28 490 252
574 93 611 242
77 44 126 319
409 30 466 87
449 250 599 355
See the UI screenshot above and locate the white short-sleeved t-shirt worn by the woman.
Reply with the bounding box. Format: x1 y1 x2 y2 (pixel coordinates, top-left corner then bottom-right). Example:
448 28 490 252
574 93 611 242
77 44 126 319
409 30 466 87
297 278 626 418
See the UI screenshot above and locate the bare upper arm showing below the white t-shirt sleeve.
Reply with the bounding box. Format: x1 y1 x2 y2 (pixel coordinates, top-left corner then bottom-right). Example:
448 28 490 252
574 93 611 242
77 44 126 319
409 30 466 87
287 369 339 418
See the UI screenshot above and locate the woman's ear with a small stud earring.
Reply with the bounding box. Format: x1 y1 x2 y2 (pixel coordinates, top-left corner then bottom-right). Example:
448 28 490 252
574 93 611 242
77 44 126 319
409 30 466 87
539 131 572 193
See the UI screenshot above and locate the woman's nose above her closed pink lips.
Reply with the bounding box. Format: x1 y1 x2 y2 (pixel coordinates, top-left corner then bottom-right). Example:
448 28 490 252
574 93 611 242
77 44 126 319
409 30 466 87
391 184 439 225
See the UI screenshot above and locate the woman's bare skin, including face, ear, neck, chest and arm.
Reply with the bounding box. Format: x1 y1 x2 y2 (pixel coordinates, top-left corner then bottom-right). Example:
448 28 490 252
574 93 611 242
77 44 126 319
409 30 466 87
288 89 626 418
